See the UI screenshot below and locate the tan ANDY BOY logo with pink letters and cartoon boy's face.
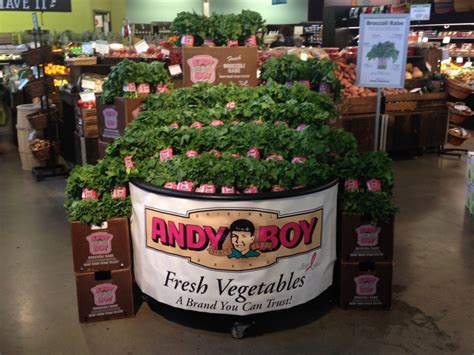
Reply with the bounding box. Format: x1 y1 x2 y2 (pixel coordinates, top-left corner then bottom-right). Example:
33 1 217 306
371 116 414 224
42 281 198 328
145 208 323 270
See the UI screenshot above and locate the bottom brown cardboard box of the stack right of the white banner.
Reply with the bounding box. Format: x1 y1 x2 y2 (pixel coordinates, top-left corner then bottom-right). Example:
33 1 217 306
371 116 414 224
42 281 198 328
339 262 393 309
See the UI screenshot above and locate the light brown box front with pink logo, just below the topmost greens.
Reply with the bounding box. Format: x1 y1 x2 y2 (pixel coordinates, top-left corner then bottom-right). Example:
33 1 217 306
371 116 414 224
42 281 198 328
183 47 257 86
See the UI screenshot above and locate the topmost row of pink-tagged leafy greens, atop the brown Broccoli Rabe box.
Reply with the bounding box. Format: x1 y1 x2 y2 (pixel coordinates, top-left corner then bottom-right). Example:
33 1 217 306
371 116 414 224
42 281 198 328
171 10 265 47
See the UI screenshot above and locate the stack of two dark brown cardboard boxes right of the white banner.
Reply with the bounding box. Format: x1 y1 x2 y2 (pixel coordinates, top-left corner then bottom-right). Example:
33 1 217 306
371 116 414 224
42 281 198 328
336 214 394 309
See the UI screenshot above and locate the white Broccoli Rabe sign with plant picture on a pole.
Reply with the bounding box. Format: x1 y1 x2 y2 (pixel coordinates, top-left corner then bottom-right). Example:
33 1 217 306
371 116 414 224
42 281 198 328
357 14 410 88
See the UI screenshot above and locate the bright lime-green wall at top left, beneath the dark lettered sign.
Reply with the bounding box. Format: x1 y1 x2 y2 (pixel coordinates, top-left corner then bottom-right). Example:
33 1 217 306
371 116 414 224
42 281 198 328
0 0 126 32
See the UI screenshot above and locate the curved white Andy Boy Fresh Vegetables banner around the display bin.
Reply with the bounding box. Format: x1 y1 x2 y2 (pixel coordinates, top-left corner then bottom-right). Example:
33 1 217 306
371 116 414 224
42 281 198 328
130 183 337 315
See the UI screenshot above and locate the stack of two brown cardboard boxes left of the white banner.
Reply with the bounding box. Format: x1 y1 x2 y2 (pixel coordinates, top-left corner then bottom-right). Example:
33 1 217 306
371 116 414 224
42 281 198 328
71 218 134 322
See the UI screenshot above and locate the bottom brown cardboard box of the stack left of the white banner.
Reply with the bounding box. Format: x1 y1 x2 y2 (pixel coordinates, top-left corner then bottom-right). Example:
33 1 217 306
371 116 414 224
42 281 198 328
76 269 134 322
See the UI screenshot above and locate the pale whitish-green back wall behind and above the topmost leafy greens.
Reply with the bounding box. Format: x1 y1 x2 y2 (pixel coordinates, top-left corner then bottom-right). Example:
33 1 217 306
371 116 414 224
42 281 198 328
127 0 308 24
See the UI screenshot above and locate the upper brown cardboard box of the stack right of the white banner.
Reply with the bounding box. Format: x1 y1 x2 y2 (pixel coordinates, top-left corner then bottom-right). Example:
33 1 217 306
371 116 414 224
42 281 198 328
337 213 394 262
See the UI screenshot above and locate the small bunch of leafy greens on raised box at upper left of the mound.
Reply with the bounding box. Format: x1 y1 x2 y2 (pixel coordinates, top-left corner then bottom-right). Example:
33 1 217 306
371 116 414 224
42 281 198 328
100 59 171 104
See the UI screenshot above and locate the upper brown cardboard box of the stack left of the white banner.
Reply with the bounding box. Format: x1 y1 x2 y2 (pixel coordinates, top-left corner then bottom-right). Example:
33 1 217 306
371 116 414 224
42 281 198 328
71 218 132 272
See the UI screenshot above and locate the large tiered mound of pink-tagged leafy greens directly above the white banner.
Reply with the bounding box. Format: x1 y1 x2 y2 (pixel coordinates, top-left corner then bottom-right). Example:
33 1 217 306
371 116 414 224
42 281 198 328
66 82 396 223
